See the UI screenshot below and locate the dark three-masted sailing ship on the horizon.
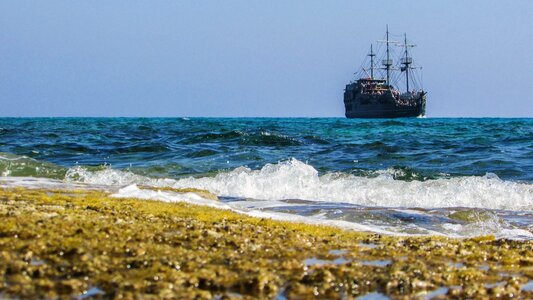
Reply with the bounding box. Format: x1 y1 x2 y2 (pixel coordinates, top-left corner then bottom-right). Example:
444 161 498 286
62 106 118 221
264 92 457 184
344 26 427 118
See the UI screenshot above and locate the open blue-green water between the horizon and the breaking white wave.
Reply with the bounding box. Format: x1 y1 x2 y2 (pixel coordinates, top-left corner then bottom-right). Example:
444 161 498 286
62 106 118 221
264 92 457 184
0 118 533 182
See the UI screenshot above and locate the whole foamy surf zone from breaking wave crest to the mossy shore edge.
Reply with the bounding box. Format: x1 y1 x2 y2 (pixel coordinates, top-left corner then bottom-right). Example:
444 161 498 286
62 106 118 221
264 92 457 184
0 159 533 239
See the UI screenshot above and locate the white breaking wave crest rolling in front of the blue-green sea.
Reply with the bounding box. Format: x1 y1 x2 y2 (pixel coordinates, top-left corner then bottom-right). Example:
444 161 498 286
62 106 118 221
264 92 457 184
66 159 533 211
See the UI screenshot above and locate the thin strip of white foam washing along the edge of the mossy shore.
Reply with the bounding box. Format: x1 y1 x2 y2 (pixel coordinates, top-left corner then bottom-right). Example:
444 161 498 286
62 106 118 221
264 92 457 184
107 185 533 239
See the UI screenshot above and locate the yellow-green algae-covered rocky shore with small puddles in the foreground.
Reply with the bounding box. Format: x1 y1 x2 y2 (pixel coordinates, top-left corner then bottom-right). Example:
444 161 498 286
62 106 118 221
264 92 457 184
0 188 533 299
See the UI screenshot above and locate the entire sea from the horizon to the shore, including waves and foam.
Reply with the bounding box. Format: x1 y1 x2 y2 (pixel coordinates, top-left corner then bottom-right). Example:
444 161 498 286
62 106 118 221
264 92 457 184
0 118 533 239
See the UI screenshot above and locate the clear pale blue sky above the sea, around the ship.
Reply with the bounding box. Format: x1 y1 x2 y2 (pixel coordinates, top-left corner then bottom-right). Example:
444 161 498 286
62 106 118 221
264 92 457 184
0 0 533 117
